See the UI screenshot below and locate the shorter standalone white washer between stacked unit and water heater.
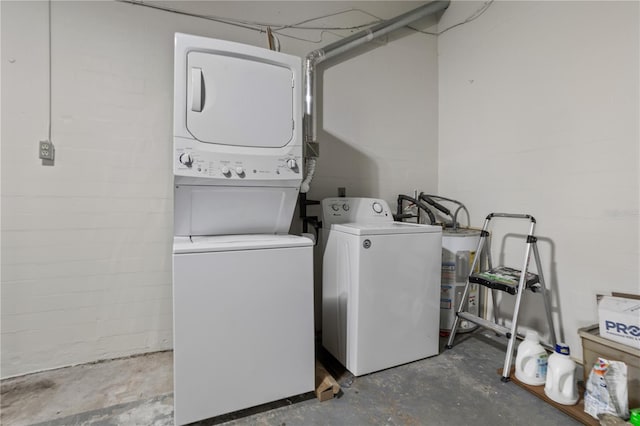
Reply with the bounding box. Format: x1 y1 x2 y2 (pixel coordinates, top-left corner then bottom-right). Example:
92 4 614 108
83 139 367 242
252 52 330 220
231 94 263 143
322 198 442 376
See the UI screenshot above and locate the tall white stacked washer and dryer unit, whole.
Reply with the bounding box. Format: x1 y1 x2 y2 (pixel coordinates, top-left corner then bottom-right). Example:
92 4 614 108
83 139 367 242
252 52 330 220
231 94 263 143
173 34 314 425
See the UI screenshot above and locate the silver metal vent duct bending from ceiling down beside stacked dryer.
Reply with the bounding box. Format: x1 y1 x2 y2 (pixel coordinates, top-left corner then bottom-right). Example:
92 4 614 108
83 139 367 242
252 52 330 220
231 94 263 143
303 0 450 153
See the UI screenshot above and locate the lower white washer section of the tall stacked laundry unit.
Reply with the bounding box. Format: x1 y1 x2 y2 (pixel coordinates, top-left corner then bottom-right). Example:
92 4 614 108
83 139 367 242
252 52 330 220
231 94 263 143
173 235 315 424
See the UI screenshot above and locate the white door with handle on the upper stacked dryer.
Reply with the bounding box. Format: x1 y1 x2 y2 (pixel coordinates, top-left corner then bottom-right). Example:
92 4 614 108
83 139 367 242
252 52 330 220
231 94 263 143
186 51 294 148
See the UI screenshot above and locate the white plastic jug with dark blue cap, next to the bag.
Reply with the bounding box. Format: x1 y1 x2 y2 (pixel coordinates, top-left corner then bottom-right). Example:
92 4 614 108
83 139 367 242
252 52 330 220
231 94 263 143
544 343 578 405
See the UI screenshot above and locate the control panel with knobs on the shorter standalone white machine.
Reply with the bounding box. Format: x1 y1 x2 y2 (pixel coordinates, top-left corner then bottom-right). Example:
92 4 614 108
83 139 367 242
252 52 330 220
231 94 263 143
321 197 393 229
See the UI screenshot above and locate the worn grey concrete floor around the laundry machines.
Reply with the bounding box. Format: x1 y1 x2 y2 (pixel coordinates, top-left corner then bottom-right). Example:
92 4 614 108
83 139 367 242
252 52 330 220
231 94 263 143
0 331 579 426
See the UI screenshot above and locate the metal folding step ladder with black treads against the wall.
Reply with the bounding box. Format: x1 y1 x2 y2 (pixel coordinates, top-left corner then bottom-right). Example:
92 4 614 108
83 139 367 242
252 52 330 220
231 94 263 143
446 213 556 382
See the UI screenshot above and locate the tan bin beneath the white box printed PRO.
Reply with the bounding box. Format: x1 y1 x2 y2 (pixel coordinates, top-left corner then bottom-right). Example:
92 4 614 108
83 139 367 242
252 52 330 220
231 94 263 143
578 324 640 408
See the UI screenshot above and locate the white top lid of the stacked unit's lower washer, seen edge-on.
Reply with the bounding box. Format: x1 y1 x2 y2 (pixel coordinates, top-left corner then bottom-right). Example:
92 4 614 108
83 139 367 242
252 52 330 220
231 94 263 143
173 234 313 254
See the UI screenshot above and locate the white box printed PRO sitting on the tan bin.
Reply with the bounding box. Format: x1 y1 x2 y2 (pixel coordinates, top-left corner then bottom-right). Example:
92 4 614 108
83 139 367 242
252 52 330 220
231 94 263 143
598 296 640 349
